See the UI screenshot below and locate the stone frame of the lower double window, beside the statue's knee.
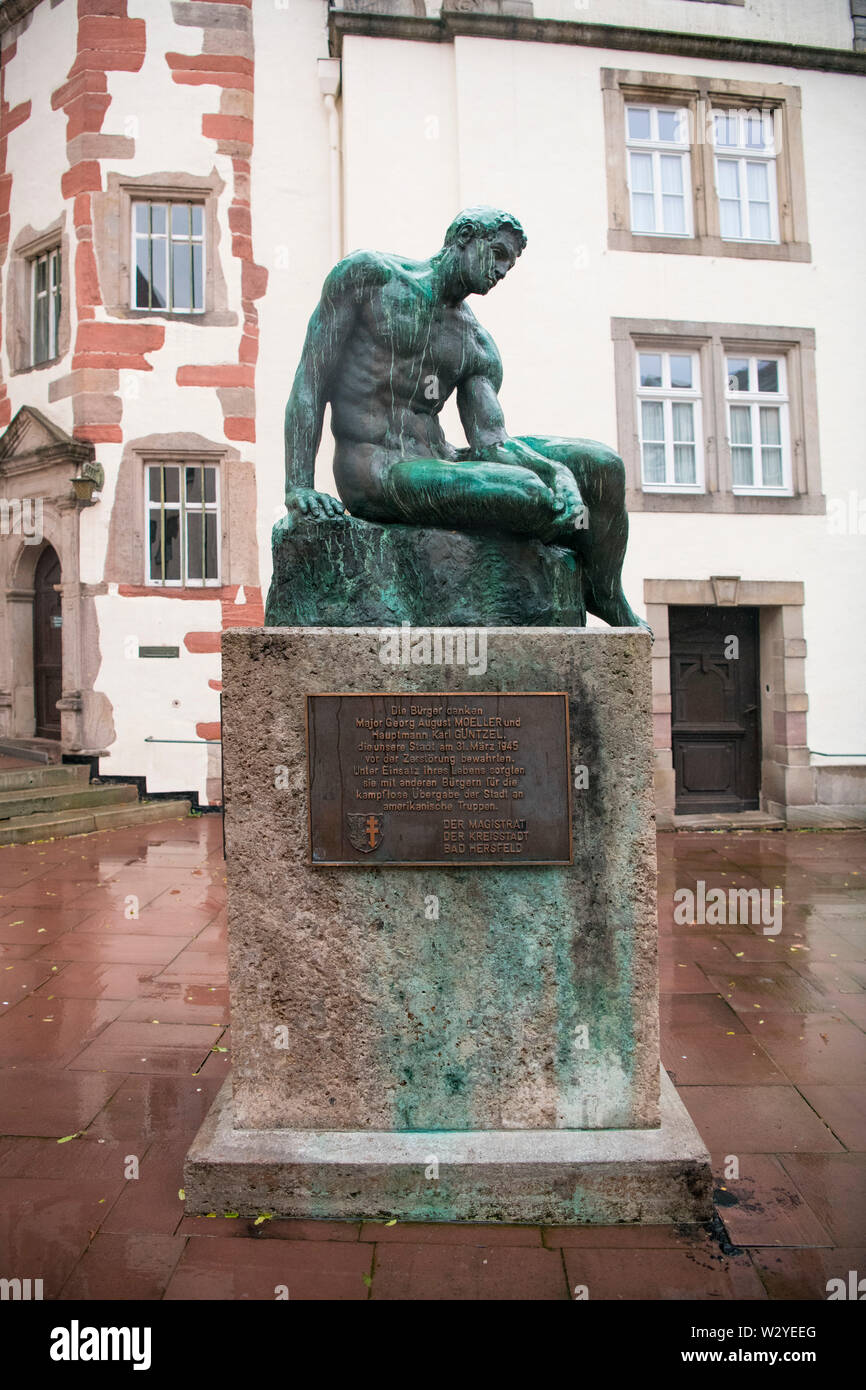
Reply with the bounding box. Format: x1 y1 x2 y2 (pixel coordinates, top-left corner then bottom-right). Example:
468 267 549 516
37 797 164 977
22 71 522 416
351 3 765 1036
610 318 827 516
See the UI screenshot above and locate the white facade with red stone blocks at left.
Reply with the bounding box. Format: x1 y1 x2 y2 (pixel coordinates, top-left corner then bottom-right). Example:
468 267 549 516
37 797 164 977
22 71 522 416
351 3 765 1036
0 0 268 802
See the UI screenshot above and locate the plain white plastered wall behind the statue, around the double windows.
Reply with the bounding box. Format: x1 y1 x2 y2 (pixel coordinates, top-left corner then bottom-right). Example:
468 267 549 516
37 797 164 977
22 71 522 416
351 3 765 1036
326 35 866 753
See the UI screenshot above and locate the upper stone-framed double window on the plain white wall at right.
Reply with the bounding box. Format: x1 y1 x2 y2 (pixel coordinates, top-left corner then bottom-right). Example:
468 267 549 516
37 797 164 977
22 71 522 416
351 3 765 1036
602 69 811 261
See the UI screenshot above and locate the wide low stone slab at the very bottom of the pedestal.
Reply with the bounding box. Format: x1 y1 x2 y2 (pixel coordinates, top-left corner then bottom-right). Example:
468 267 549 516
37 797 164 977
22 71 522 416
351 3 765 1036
183 1069 712 1226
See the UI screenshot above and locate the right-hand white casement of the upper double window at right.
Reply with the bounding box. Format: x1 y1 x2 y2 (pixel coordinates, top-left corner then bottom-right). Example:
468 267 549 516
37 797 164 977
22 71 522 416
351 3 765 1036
713 110 778 242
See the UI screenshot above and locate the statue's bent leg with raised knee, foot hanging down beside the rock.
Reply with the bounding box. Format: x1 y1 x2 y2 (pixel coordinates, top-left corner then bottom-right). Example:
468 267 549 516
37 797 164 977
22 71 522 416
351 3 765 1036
514 435 649 631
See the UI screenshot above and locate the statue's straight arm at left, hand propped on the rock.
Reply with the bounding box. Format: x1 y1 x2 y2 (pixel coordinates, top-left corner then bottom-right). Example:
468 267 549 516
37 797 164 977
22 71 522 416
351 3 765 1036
285 254 364 520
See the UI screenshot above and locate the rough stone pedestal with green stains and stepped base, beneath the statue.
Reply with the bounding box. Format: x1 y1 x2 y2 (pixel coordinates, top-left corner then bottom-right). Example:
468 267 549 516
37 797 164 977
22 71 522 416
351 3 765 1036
185 627 710 1222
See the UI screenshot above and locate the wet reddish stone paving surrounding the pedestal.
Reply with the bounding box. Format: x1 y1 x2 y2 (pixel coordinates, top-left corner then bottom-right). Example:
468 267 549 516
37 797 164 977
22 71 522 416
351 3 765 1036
0 816 866 1302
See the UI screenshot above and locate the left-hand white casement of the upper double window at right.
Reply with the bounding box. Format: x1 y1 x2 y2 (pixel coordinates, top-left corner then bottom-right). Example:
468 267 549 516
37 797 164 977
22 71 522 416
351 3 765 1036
626 106 692 236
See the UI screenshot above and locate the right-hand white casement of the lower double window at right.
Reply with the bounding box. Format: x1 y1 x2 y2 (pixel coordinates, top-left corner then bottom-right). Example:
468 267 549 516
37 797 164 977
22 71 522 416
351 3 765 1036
726 357 791 493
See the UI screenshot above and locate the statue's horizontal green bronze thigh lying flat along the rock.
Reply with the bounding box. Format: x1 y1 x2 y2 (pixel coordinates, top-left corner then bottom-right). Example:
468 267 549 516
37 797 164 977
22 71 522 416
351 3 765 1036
353 459 556 537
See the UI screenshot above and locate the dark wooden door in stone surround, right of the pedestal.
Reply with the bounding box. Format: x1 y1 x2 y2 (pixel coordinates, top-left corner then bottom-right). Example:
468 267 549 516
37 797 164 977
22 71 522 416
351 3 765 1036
669 607 760 815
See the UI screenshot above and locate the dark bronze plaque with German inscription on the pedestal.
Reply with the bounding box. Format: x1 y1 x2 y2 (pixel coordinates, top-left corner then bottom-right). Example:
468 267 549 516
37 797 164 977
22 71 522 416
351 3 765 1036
307 691 571 867
